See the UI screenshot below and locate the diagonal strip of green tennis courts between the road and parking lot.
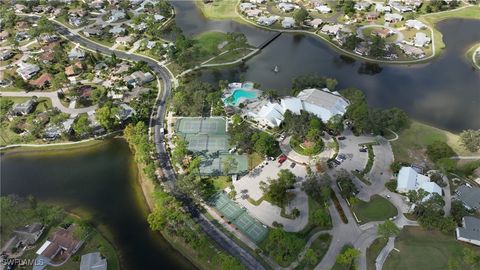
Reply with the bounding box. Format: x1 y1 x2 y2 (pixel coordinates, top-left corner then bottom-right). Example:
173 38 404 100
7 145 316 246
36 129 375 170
210 192 268 243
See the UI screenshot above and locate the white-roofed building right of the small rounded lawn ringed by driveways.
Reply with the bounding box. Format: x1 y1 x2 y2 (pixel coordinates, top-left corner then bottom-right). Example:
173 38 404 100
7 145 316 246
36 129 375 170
397 167 442 196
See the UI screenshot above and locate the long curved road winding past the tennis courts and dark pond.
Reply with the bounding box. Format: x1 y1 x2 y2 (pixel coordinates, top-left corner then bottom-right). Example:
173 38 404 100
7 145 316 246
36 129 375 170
19 14 265 269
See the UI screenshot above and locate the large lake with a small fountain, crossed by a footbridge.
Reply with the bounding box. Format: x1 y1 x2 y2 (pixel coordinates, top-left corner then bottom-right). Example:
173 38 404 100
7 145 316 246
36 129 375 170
172 1 480 131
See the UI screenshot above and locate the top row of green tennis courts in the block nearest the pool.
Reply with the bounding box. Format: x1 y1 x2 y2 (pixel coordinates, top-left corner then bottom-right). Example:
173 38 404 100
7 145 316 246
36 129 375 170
176 118 226 134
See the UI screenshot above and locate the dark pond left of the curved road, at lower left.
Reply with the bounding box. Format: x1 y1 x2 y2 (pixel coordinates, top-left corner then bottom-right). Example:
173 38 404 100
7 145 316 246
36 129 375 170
0 140 195 269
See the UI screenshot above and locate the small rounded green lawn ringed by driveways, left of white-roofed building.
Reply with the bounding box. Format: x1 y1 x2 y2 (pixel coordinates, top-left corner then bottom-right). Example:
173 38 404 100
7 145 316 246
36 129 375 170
352 195 398 223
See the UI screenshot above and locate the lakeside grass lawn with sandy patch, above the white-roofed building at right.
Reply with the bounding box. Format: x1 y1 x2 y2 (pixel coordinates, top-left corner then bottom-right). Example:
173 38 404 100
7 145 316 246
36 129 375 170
391 121 479 162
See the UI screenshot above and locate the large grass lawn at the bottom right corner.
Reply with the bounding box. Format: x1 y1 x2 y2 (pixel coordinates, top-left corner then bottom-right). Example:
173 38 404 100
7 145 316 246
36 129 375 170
383 227 480 270
